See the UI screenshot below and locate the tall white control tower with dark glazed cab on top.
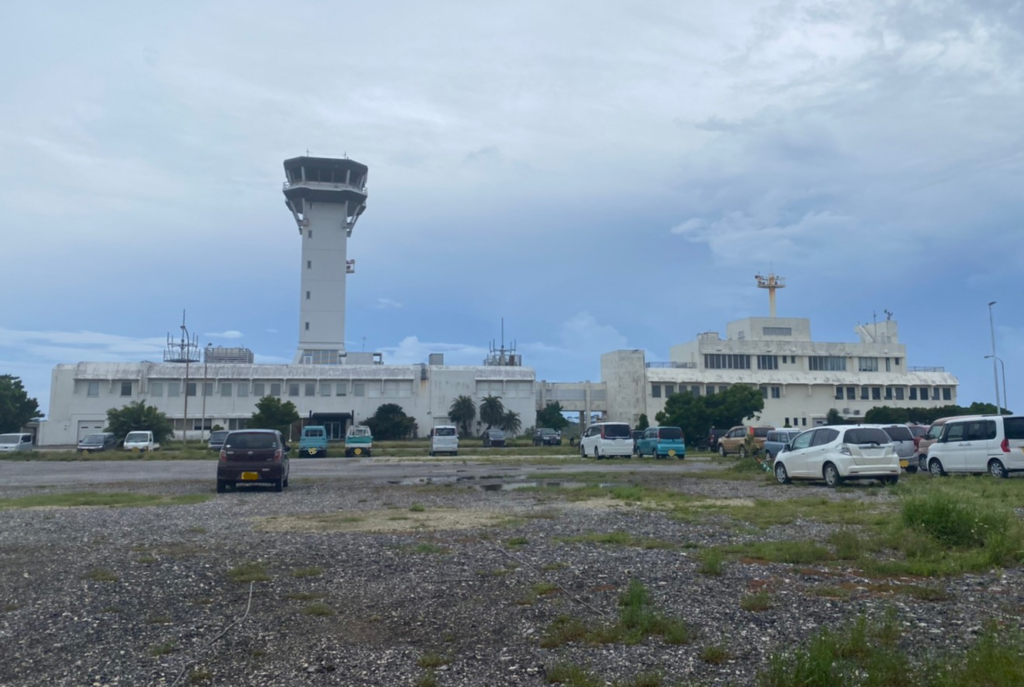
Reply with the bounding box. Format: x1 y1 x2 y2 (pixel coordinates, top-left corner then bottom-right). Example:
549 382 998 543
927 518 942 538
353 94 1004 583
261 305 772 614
285 157 369 364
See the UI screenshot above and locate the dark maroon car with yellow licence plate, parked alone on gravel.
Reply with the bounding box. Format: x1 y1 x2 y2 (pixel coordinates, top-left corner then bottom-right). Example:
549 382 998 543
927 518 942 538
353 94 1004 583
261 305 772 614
217 429 292 493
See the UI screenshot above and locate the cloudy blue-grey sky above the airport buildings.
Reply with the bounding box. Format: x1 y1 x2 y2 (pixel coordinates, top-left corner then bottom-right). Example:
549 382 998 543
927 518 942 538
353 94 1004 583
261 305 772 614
0 0 1024 411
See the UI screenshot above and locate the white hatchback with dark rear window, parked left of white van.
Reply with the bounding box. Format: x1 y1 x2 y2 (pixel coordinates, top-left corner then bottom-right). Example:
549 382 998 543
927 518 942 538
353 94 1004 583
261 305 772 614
773 425 900 486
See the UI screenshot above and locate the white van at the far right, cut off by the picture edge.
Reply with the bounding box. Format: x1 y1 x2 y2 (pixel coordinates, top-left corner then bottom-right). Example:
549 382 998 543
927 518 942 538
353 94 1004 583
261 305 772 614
928 415 1024 477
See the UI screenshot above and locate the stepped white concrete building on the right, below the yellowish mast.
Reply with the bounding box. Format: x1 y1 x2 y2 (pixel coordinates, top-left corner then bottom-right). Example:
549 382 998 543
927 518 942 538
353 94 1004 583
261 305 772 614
601 317 957 427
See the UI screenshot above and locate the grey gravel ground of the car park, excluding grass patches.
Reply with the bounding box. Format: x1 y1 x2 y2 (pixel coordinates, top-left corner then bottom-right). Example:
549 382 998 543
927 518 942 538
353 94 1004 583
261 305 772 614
0 476 1024 686
